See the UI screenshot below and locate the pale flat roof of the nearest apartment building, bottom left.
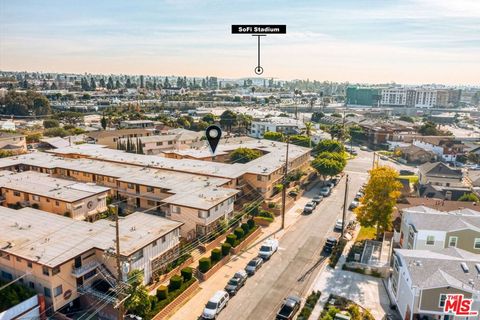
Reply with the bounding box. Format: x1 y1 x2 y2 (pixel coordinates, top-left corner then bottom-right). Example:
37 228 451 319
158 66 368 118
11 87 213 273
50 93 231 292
0 207 182 267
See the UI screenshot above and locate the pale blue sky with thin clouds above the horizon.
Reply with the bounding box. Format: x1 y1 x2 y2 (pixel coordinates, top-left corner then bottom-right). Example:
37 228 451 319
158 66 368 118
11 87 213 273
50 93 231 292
0 0 480 85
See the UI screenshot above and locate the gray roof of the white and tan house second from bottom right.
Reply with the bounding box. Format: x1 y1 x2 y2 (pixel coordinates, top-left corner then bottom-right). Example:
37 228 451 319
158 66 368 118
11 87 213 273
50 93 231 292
403 206 480 232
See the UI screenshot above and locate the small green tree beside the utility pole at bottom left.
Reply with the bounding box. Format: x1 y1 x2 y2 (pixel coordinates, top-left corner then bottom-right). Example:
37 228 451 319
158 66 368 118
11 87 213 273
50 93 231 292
125 270 151 318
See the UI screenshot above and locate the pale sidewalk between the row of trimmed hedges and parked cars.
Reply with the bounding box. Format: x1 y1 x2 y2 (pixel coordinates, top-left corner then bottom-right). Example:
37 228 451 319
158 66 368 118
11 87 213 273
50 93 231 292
170 188 317 320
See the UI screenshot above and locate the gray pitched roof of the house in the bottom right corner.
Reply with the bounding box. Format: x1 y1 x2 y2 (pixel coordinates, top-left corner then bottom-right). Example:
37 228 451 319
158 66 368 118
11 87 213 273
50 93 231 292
395 248 480 292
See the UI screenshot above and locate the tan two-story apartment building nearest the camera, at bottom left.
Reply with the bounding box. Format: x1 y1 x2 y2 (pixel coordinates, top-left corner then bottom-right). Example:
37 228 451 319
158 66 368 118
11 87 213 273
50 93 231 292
0 207 181 312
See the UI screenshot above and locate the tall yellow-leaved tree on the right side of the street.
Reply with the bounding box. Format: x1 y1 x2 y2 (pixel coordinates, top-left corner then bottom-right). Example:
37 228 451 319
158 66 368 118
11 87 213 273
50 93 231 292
355 166 402 236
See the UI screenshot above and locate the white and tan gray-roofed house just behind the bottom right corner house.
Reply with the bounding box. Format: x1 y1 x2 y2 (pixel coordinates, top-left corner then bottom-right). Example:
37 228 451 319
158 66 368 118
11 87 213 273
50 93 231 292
399 206 480 255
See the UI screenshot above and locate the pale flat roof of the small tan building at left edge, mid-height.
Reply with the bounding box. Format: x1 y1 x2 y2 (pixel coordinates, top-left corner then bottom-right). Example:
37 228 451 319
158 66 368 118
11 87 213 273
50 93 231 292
0 170 110 202
